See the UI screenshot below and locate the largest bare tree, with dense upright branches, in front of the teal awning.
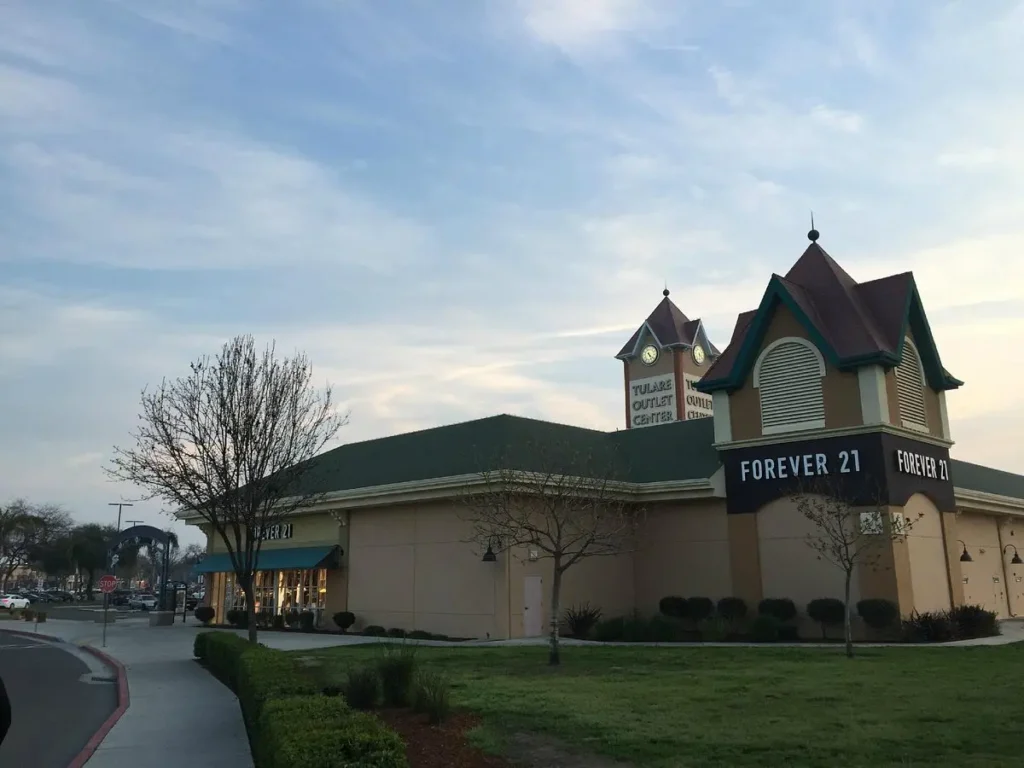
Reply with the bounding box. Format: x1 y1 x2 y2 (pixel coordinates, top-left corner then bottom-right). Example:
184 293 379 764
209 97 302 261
108 336 347 643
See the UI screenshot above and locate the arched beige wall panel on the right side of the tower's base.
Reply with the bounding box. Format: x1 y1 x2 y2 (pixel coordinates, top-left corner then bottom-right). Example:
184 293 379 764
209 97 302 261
894 494 950 613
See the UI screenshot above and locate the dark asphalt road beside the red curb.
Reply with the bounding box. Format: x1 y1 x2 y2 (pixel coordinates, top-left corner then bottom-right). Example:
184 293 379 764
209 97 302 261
0 632 118 768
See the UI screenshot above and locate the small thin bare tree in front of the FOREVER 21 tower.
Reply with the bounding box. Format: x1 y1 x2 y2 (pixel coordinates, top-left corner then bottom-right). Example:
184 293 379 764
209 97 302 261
793 479 922 658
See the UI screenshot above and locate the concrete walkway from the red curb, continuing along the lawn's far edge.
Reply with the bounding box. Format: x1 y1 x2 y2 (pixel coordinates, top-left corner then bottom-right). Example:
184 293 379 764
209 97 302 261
0 618 1024 768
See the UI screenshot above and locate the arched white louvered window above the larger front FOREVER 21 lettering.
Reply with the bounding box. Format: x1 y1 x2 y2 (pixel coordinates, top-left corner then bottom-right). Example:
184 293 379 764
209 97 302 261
754 339 825 434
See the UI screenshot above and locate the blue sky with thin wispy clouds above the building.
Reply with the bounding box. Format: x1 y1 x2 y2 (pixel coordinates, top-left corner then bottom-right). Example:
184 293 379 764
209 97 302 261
0 0 1024 542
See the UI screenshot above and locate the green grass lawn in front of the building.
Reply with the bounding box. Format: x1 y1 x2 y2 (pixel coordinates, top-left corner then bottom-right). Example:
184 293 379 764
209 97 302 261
302 644 1024 768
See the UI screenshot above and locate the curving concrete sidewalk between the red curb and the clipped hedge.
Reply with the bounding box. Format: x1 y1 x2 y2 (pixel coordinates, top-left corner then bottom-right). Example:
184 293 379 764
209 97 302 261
0 618 253 768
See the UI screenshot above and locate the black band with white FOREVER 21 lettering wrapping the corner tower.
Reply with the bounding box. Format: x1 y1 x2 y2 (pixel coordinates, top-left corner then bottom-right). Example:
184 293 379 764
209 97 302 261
722 432 955 513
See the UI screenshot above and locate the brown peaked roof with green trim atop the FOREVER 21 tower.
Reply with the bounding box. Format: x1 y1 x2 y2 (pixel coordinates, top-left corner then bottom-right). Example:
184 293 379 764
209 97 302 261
698 243 963 392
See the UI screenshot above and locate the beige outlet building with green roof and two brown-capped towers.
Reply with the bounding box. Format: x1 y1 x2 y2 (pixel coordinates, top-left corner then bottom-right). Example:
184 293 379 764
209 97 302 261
184 231 1024 638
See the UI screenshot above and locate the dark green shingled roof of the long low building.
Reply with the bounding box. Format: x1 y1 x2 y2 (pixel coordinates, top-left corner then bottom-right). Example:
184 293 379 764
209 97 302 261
282 415 1024 499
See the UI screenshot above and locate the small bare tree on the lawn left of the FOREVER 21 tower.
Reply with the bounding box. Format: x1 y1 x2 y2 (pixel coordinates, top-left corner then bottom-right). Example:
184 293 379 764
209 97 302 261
462 442 643 666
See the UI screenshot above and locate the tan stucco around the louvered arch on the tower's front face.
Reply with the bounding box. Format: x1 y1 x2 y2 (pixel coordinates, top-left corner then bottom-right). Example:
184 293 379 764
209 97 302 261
729 306 863 440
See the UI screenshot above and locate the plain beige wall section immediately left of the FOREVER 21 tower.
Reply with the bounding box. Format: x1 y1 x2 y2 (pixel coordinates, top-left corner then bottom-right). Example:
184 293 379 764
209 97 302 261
635 500 733 615
